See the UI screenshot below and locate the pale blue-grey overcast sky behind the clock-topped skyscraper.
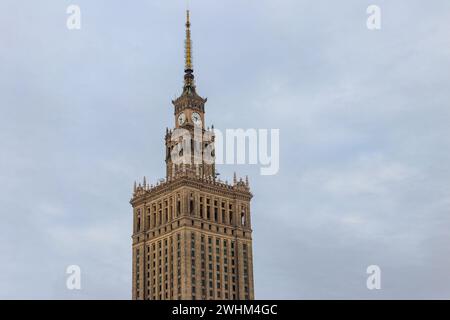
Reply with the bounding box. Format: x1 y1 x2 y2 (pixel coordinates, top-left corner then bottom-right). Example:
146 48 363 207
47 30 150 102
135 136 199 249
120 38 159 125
0 0 450 299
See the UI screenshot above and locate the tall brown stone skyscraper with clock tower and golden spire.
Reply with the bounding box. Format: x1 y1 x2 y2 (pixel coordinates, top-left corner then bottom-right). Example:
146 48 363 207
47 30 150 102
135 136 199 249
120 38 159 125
130 11 254 300
